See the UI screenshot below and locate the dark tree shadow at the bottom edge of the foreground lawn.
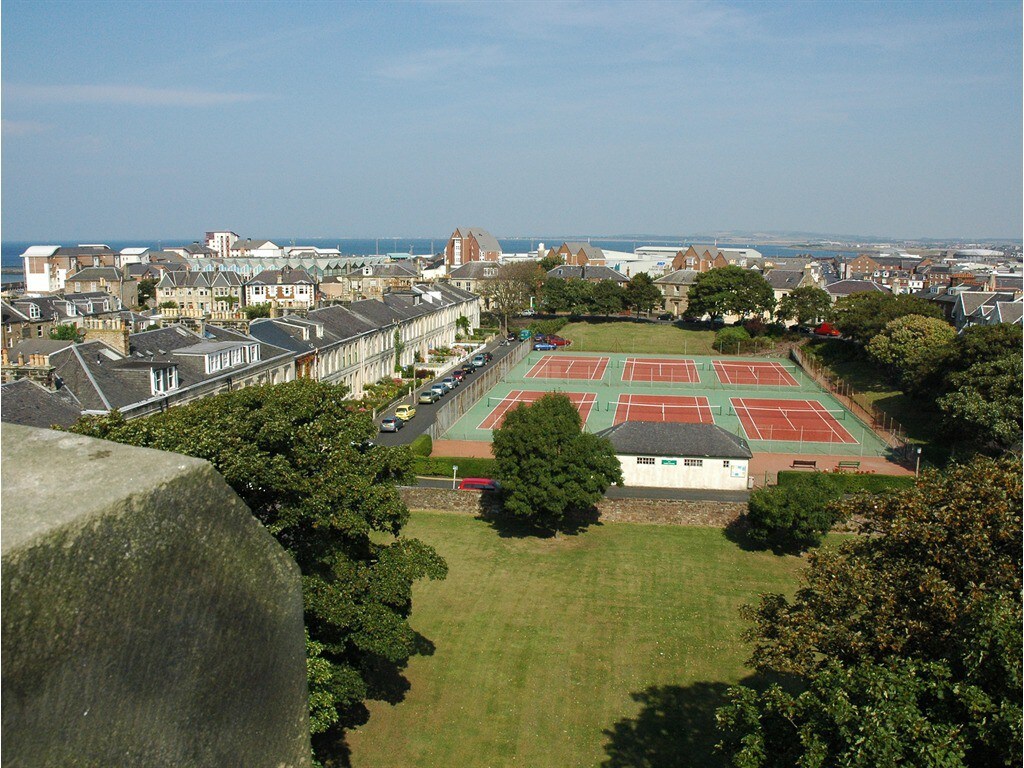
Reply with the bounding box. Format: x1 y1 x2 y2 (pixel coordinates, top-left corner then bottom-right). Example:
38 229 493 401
601 675 794 768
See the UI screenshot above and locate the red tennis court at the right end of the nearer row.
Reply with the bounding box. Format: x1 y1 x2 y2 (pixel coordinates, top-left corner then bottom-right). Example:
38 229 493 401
729 397 857 442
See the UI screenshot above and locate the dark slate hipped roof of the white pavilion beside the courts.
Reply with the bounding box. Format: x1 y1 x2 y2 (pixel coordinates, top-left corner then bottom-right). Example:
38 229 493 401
597 421 753 459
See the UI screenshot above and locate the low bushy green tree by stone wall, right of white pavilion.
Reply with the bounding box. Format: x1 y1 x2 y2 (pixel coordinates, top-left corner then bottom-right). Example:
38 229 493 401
746 474 843 552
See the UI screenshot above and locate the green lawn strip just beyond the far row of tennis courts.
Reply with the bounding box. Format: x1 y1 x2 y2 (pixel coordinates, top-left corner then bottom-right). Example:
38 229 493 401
559 321 718 354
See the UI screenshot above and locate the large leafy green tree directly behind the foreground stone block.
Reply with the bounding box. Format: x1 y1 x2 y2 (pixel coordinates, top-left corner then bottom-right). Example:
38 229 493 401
66 379 446 757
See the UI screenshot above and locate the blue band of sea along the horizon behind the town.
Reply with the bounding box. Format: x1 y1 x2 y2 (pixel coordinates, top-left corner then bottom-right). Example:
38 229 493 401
0 234 860 284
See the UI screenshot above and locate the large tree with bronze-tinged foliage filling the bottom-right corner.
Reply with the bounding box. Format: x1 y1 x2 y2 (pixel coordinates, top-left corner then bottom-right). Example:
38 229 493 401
719 458 1022 768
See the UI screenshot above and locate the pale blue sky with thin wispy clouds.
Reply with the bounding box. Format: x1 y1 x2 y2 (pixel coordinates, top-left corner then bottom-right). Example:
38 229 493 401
0 0 1024 243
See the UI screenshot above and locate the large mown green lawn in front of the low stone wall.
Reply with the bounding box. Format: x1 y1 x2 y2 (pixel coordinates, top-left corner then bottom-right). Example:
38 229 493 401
348 512 804 768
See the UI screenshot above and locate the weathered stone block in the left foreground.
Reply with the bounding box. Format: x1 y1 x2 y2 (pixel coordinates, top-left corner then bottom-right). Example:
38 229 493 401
0 424 310 768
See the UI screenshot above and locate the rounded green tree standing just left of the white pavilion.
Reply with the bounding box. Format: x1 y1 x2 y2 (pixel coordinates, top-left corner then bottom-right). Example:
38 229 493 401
493 393 623 529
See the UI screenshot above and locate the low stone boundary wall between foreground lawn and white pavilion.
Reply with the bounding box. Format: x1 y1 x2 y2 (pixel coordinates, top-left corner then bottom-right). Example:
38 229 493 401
400 487 746 527
